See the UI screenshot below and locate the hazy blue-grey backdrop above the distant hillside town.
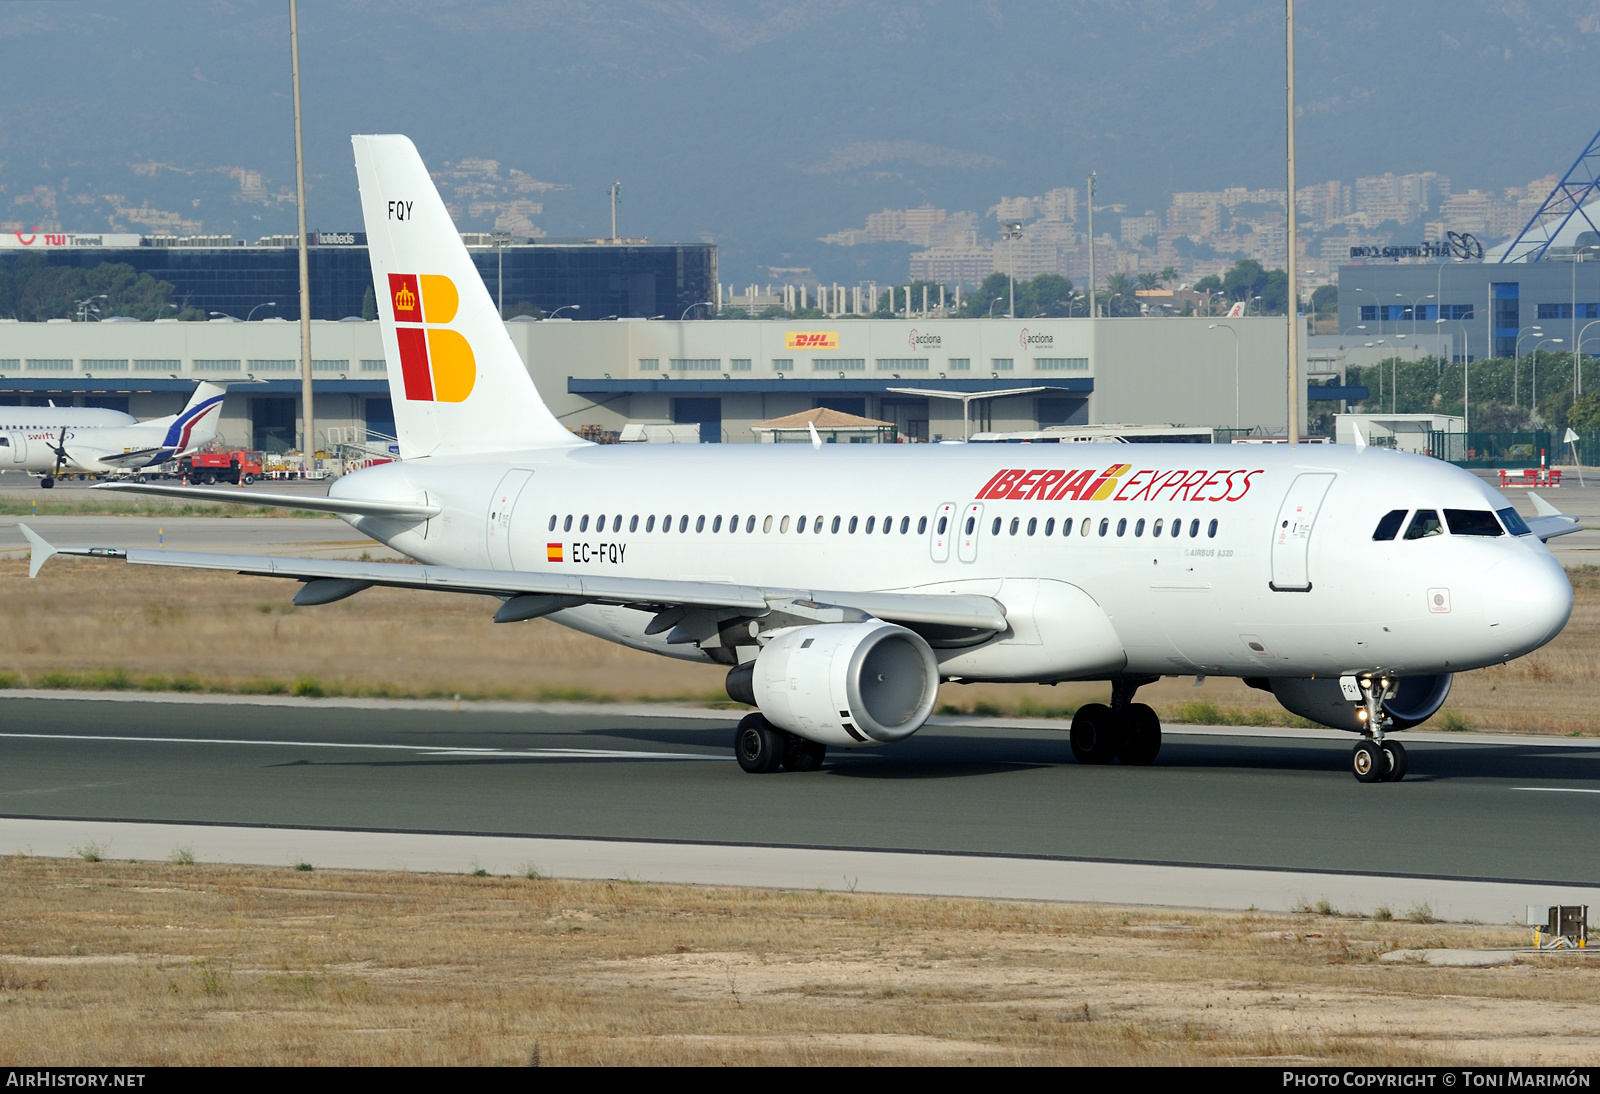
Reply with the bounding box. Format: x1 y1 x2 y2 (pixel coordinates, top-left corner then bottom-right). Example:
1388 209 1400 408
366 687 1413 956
0 0 1600 280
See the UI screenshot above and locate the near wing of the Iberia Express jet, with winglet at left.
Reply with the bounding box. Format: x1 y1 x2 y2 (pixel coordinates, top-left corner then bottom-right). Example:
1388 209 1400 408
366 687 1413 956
18 527 1008 645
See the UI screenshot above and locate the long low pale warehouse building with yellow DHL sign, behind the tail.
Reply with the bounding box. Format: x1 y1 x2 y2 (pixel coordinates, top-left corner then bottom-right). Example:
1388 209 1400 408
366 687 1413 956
0 311 1299 451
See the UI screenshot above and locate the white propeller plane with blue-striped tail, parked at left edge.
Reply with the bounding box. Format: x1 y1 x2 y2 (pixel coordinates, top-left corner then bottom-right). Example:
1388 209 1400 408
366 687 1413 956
0 382 227 489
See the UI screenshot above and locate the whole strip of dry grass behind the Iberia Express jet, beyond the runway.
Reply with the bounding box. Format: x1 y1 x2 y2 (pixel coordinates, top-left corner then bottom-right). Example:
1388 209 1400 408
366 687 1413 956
0 558 1600 736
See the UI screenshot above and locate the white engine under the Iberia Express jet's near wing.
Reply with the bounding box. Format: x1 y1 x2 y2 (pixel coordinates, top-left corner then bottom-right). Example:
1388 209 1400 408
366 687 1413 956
728 619 939 747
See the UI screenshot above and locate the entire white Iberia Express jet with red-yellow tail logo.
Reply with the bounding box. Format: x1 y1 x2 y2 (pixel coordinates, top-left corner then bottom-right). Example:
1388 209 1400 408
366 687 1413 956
18 136 1576 782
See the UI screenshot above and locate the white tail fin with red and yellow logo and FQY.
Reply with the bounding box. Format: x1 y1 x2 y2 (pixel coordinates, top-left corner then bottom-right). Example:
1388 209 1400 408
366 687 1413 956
350 134 586 459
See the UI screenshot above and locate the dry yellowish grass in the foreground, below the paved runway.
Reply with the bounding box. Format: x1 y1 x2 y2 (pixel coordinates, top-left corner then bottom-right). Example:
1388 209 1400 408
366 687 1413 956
0 857 1600 1065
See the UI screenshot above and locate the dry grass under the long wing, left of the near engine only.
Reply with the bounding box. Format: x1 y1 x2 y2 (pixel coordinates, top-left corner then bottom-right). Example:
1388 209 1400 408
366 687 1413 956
0 558 726 702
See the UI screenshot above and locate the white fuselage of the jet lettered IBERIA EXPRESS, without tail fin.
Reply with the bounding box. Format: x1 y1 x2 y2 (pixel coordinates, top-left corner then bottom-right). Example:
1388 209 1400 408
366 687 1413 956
331 445 1573 680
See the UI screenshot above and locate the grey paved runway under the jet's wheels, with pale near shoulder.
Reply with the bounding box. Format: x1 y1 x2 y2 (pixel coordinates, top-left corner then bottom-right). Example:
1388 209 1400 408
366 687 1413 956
0 697 1600 921
